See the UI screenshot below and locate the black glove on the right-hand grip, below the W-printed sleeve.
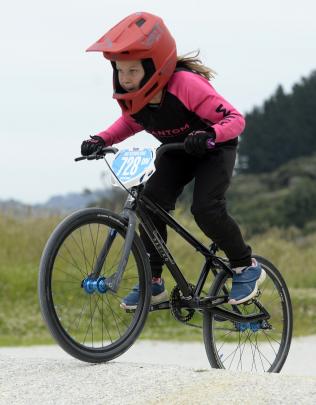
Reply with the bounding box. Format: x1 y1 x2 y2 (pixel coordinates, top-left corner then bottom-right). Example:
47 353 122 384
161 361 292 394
184 129 216 156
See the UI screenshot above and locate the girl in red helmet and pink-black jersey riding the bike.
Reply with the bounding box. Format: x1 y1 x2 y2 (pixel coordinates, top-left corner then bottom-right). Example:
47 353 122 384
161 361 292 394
81 12 265 308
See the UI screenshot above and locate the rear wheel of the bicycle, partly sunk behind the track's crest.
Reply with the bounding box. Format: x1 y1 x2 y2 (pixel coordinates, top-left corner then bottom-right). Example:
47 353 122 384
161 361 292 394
203 256 293 372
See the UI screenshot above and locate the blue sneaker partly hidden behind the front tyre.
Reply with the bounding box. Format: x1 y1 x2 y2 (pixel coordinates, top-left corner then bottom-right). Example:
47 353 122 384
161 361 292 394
120 278 169 309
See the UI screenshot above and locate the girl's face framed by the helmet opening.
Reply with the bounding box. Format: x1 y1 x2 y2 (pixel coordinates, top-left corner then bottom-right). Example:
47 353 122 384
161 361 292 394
116 60 145 93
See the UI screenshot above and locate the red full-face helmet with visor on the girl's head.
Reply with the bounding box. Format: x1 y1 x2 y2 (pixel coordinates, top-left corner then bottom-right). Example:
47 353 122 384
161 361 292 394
87 12 177 114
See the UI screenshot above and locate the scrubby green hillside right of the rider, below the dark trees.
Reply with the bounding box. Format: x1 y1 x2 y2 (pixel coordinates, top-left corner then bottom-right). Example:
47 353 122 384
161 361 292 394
227 154 316 234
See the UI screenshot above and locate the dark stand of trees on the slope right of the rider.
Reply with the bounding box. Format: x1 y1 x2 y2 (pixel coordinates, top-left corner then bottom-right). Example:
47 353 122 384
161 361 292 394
237 70 316 173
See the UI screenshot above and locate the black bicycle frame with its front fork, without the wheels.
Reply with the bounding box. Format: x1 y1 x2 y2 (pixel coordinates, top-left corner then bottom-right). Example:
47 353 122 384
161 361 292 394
91 186 270 322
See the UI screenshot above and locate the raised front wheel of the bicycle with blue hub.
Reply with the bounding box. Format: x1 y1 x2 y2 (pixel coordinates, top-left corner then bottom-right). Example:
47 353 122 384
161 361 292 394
39 208 151 363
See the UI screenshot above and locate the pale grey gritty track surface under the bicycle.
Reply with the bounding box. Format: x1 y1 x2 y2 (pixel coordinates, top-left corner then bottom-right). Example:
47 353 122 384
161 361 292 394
0 336 316 405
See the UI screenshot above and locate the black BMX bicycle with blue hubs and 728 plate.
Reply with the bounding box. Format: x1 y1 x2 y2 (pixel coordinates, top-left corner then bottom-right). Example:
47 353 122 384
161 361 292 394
39 144 293 372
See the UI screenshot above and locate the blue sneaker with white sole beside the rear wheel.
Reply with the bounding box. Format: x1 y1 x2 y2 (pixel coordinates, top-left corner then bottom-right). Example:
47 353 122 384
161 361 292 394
228 259 266 305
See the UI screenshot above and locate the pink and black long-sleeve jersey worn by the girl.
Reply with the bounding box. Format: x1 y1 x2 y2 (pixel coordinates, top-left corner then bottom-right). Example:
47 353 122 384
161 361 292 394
98 70 245 145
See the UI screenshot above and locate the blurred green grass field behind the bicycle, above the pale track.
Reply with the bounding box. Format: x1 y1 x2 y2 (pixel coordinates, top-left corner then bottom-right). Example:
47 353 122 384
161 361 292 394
0 211 316 345
